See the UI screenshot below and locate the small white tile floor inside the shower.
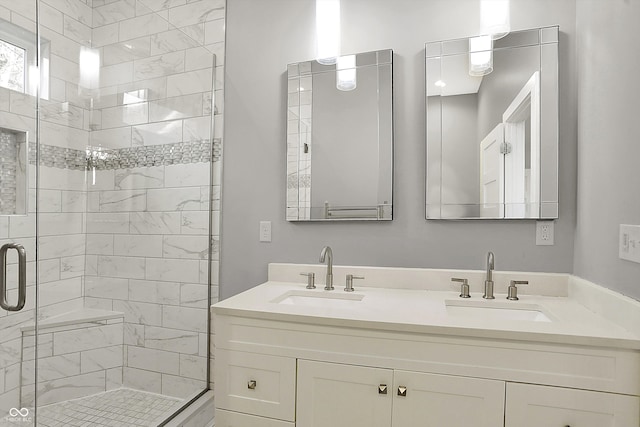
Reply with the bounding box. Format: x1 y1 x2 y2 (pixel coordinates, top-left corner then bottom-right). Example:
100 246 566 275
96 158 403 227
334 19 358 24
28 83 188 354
0 388 184 427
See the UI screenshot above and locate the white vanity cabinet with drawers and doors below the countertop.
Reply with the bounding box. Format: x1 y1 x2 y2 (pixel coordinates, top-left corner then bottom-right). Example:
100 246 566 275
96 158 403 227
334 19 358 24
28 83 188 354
214 310 640 427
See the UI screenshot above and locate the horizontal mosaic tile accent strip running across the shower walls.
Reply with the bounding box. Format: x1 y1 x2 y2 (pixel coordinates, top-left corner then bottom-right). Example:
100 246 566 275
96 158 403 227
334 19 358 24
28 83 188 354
29 138 222 170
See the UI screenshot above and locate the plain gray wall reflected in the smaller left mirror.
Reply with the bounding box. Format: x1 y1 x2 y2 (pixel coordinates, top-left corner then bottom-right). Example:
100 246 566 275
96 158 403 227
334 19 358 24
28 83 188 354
311 66 379 208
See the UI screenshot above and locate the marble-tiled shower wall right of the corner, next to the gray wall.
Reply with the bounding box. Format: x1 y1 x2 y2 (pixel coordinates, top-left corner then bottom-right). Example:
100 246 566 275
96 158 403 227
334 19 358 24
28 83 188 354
85 0 225 398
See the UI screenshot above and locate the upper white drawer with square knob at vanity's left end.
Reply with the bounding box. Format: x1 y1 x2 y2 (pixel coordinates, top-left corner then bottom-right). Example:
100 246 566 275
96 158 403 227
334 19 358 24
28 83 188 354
215 349 296 421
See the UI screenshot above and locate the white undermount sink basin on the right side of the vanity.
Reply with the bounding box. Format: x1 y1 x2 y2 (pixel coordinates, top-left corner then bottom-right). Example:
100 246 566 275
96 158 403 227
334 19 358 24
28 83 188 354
445 300 551 322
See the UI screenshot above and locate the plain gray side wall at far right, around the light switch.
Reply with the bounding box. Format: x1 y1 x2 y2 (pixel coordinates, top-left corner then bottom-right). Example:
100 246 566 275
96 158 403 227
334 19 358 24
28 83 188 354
574 0 640 299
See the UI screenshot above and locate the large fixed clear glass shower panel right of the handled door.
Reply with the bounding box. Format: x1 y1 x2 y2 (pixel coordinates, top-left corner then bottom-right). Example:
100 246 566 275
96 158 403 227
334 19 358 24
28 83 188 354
33 0 222 426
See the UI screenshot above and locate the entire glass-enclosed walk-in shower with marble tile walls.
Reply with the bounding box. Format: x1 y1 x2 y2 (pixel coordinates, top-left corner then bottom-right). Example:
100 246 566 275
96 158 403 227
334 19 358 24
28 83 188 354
0 0 224 426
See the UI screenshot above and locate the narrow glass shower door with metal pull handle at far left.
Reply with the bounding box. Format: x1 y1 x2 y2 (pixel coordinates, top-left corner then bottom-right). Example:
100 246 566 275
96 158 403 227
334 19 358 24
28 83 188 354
0 1 40 426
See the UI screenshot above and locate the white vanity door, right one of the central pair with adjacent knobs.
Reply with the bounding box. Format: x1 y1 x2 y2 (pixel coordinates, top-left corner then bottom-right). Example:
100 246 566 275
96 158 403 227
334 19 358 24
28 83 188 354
393 371 504 427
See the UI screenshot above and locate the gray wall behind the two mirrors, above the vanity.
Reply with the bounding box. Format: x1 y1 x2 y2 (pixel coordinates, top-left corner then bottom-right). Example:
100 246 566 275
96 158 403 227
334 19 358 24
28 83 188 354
220 0 580 297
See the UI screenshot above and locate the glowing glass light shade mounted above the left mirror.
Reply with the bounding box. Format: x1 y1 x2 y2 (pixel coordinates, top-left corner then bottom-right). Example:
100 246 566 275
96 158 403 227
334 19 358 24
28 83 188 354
316 0 340 65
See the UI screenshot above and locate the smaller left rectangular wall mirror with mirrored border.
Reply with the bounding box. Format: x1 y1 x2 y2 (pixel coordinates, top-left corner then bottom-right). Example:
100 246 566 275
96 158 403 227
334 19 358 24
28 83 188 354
286 49 393 221
